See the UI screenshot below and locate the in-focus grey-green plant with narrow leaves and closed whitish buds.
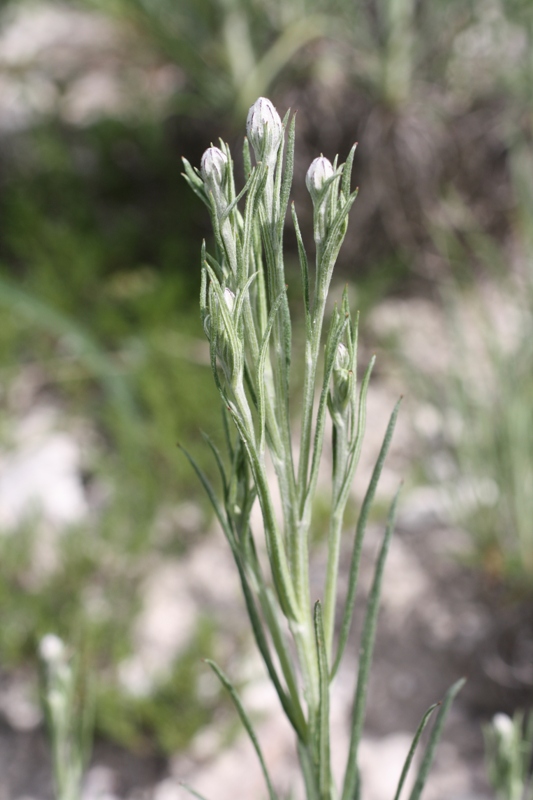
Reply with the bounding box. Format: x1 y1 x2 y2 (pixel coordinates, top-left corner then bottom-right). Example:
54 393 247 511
180 98 459 800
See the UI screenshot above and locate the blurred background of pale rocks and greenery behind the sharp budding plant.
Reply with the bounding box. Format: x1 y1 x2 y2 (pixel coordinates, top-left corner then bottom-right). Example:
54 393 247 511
0 0 533 800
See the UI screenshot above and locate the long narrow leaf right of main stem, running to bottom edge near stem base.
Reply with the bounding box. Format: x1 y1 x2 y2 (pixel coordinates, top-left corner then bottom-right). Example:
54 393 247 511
342 487 400 800
